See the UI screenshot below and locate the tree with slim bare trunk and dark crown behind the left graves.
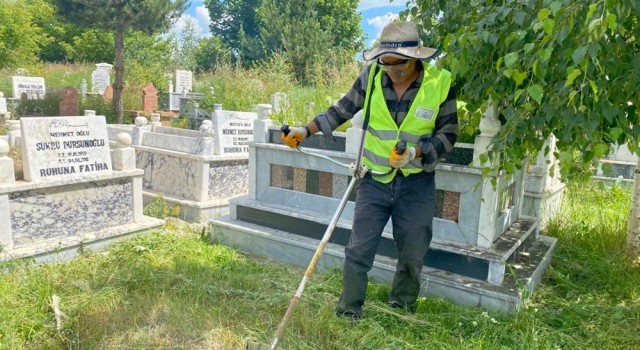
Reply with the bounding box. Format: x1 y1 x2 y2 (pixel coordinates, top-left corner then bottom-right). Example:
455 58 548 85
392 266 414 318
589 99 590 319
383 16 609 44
52 0 187 123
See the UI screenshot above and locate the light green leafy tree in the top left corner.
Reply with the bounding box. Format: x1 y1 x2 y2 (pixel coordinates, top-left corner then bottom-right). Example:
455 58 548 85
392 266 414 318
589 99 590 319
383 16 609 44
0 0 53 68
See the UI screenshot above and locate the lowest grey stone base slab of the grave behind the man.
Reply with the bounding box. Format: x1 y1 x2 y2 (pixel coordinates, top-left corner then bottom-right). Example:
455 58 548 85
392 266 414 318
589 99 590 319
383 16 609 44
210 216 555 312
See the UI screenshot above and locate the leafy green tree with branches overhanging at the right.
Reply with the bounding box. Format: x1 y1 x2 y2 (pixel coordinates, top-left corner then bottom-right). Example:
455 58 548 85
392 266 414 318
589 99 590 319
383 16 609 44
404 0 640 256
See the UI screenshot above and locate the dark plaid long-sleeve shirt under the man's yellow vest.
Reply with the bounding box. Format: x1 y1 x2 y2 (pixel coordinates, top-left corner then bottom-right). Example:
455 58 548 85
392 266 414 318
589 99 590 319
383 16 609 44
314 63 458 172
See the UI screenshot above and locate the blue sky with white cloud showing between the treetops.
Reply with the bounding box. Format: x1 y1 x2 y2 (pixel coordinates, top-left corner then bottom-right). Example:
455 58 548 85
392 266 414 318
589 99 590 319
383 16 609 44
173 0 406 47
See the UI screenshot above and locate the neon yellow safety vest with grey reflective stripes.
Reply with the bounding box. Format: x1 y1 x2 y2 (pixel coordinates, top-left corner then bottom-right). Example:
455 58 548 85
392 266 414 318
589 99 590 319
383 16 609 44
362 61 451 183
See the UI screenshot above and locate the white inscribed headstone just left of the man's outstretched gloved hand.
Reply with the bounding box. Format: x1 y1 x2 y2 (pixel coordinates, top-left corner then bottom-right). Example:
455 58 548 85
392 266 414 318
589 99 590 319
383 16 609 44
213 111 258 155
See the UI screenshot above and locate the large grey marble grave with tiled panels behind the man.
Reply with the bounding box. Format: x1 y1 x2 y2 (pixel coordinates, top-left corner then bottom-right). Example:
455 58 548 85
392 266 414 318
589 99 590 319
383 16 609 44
211 106 555 311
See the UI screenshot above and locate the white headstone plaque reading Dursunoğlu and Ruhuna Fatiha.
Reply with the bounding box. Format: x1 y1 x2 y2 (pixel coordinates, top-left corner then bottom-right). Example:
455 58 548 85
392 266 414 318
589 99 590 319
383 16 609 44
20 116 112 181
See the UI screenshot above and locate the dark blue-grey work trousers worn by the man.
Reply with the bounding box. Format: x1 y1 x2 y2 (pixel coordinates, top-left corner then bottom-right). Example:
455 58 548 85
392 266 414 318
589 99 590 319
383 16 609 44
336 172 435 316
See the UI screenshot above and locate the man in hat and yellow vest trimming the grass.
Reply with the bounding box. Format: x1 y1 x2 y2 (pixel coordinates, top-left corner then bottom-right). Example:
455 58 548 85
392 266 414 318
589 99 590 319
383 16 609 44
281 22 458 319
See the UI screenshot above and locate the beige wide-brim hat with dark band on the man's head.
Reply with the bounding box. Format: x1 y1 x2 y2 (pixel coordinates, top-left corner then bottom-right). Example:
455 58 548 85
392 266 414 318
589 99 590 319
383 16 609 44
362 22 438 61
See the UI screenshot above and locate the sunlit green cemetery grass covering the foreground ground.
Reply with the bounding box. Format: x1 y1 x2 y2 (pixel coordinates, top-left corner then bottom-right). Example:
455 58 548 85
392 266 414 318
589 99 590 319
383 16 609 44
0 184 640 350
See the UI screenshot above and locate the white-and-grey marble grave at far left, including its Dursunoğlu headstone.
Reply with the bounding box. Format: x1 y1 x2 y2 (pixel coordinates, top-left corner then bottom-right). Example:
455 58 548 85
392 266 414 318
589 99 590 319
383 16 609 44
0 116 164 261
